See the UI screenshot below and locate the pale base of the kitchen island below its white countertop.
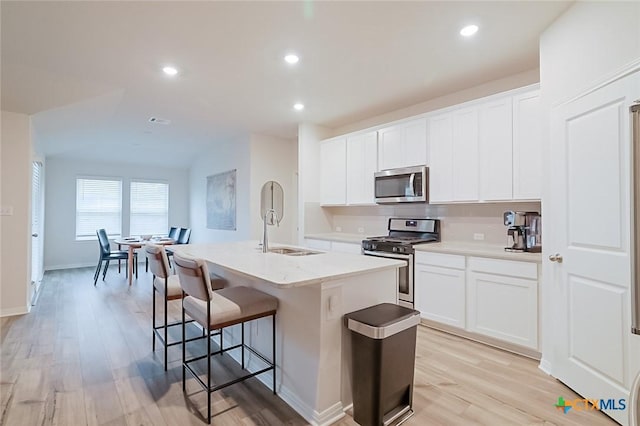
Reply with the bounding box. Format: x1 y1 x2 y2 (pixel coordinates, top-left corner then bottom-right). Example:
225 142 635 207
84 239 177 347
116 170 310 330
210 265 397 425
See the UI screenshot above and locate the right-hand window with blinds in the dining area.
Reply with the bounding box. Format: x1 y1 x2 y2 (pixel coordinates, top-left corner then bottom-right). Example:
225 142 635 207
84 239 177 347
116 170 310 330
131 182 169 235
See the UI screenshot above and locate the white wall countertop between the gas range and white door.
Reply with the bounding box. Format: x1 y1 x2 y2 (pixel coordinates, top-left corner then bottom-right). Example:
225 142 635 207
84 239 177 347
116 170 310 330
414 241 542 263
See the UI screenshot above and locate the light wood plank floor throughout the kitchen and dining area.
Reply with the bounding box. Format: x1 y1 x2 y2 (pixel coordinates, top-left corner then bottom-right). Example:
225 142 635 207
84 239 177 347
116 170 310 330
0 266 616 426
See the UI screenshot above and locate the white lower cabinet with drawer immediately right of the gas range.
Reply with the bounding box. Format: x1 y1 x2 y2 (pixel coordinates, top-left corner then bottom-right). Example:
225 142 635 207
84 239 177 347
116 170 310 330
414 253 465 328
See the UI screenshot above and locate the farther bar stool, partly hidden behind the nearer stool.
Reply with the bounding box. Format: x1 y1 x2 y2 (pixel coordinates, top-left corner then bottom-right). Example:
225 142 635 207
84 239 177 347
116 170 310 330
144 244 226 371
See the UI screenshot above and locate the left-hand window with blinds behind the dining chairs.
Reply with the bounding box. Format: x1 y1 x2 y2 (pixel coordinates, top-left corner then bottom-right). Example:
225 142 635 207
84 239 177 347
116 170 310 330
76 178 122 240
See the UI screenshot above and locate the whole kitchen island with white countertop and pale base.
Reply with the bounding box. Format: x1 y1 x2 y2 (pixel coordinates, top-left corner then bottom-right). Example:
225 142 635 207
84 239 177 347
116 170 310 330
172 241 404 425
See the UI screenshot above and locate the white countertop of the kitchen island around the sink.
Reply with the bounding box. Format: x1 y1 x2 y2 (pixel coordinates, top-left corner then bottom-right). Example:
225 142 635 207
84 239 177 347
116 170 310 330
171 241 404 288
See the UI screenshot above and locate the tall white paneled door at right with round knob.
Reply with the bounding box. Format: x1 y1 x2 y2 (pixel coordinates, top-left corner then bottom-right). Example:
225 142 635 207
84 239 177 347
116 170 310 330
545 77 640 425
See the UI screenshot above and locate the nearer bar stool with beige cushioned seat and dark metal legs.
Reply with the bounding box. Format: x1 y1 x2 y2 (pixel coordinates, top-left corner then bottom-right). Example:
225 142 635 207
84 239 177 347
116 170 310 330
173 253 278 424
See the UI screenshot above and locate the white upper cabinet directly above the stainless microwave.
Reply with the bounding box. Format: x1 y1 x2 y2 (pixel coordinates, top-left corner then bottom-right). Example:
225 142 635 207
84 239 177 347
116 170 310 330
378 118 427 170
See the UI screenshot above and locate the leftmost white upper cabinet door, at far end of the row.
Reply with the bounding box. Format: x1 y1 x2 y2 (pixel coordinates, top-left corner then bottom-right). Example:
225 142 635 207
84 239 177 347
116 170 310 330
320 137 347 205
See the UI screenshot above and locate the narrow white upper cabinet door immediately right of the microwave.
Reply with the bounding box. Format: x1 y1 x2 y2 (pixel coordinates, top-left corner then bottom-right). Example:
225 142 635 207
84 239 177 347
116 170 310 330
429 113 453 203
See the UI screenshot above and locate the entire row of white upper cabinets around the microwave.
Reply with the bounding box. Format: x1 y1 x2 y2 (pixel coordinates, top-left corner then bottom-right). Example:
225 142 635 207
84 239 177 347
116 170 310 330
320 84 543 205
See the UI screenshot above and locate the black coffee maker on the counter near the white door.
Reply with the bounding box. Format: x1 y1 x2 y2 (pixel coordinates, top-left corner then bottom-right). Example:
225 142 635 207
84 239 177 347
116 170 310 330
503 210 542 253
